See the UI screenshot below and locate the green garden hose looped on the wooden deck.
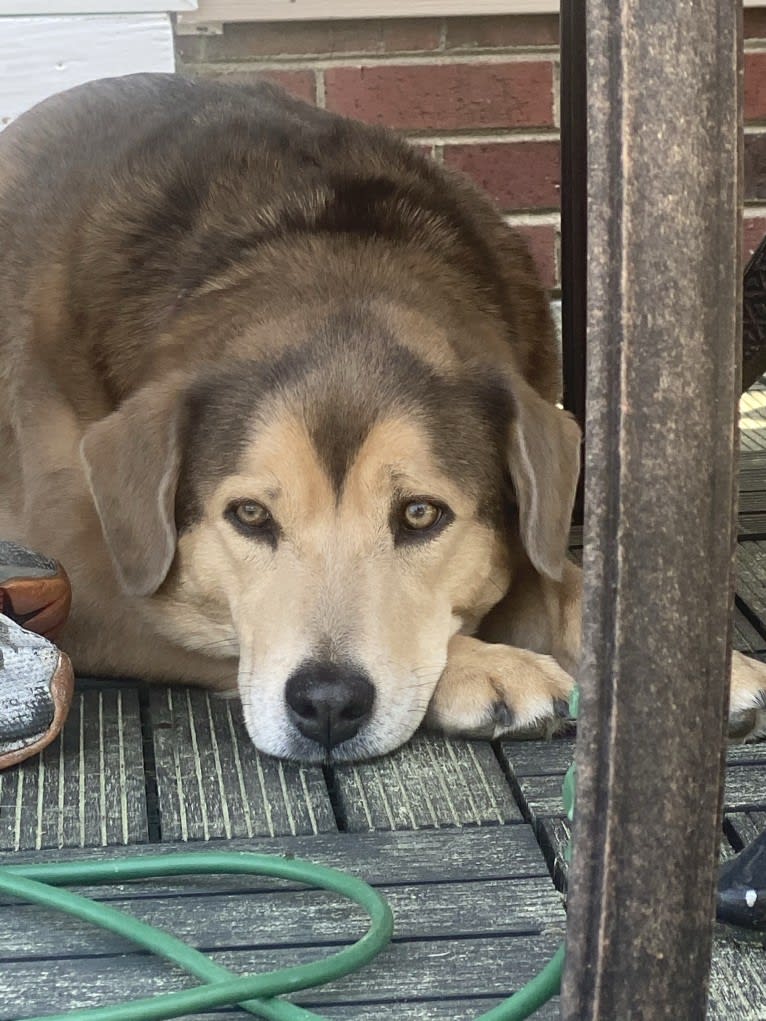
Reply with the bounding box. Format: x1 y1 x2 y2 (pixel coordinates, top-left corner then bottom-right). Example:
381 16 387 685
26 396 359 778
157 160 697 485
0 689 577 1021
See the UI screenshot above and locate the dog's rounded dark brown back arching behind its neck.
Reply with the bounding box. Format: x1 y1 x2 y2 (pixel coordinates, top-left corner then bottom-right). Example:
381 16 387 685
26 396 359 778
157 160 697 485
0 75 559 411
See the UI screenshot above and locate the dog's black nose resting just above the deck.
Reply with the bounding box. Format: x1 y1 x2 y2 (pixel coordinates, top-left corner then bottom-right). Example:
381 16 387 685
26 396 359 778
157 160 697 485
285 661 375 748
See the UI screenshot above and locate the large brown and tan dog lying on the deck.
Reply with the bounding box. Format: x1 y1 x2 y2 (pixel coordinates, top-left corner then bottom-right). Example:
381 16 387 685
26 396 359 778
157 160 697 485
0 75 766 762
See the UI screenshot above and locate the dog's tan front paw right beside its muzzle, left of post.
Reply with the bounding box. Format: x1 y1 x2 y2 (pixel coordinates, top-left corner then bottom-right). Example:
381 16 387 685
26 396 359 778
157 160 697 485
425 635 573 738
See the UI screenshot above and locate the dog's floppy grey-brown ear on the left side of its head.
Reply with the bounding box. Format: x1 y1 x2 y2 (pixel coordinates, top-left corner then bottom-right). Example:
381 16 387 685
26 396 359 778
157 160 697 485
80 383 182 595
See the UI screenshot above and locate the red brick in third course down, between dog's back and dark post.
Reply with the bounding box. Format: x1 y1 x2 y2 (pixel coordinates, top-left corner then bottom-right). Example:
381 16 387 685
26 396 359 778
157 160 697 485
444 141 561 209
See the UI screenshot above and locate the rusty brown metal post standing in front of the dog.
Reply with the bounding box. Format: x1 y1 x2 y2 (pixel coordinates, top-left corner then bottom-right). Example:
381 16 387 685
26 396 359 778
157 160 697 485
562 0 741 1021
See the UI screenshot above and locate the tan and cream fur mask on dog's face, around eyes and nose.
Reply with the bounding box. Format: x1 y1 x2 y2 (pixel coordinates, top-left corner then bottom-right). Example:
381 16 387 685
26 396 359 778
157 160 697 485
154 407 510 755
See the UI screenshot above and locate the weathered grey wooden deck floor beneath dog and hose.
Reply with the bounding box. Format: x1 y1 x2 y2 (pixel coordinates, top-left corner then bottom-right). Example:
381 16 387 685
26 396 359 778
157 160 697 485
0 388 766 1021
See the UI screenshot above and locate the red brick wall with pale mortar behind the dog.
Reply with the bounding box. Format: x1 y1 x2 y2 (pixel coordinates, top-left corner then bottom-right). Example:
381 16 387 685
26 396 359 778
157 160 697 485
177 9 766 291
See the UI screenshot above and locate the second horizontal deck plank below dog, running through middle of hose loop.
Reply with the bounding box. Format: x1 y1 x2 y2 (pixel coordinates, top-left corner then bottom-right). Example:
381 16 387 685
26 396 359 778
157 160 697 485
0 876 562 963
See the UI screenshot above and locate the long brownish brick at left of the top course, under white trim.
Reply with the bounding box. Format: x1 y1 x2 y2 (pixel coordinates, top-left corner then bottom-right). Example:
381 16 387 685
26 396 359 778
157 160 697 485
176 17 442 63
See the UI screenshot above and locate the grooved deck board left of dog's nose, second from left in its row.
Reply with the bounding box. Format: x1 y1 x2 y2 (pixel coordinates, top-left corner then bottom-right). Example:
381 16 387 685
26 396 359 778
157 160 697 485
149 687 337 841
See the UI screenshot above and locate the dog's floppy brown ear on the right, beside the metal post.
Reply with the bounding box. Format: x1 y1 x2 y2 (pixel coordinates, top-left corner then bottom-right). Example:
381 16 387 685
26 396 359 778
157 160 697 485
509 378 580 581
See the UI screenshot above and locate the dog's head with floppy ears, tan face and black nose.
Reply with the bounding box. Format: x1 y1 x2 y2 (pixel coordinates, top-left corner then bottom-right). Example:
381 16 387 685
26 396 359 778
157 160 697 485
83 321 579 761
